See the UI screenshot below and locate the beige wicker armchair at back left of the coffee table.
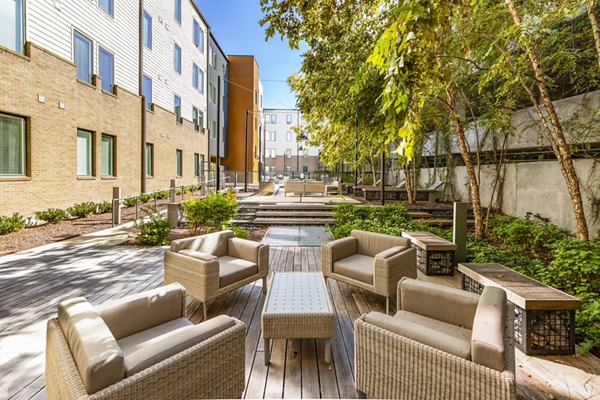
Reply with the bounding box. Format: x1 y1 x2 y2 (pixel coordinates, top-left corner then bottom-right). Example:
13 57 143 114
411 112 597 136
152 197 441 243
164 231 269 319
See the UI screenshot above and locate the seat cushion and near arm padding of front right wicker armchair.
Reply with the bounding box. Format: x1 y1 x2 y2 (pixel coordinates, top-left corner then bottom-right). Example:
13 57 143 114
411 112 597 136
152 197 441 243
365 311 471 360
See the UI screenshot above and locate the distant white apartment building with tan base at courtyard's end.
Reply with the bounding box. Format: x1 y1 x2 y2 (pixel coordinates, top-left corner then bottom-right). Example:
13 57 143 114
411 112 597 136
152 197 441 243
263 108 319 177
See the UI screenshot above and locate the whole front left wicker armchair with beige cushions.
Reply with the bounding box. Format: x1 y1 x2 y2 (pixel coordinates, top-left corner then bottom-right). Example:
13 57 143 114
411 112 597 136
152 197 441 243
45 285 246 400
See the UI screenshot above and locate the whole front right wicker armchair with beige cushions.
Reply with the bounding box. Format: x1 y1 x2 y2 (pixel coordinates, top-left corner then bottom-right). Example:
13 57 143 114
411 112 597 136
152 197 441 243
354 279 516 400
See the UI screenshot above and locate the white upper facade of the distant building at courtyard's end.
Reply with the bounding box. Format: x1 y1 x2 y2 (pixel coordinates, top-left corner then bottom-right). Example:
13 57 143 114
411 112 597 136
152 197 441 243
263 108 319 157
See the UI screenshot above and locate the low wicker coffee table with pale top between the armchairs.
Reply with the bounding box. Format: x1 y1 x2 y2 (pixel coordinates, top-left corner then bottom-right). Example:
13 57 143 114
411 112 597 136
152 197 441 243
261 272 335 365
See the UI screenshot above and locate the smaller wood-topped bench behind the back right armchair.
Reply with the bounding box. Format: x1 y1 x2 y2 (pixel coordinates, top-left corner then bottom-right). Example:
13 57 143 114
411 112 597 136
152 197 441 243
402 232 456 275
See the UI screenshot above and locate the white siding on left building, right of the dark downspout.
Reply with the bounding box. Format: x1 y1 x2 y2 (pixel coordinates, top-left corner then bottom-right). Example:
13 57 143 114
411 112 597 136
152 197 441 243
144 0 208 124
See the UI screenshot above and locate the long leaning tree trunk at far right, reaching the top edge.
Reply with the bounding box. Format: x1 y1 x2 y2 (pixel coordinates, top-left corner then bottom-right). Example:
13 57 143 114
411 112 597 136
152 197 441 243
506 0 589 240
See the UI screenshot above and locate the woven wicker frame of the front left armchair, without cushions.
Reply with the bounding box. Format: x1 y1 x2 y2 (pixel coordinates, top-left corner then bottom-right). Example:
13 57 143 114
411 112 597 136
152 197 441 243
45 319 246 400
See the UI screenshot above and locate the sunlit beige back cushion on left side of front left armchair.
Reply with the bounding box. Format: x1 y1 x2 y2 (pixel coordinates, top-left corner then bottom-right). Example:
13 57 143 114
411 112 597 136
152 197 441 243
58 297 125 394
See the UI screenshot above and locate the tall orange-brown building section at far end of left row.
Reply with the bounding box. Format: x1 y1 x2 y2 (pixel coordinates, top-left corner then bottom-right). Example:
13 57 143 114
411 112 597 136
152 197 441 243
222 55 262 182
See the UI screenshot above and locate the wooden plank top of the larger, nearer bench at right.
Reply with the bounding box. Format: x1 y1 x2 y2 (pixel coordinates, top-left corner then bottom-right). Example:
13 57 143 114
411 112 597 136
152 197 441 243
458 263 581 310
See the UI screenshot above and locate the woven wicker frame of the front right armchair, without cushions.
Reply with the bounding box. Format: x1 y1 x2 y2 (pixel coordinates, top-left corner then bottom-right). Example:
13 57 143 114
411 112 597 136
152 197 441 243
354 310 516 400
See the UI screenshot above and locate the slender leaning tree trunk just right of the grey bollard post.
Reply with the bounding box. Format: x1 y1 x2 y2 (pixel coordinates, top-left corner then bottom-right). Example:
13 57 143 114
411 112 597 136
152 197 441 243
446 87 485 239
